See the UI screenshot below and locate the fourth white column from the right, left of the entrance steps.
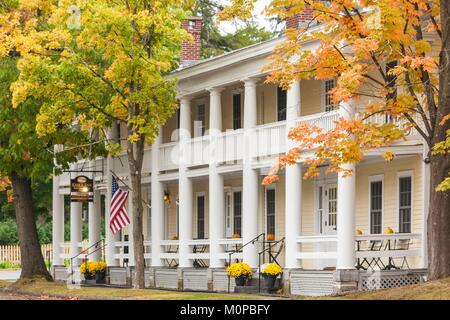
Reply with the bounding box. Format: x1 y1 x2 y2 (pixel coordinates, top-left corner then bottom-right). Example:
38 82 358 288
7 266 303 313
209 88 225 268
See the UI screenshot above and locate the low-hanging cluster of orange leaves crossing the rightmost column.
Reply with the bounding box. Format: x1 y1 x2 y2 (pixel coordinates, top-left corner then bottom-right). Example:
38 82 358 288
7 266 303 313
262 118 408 185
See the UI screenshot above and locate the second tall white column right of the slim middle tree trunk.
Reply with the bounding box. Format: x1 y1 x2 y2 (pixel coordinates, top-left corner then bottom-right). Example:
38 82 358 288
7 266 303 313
178 97 193 268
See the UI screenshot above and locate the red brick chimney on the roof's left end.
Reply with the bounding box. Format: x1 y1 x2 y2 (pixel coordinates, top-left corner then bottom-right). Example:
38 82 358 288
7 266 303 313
180 17 202 67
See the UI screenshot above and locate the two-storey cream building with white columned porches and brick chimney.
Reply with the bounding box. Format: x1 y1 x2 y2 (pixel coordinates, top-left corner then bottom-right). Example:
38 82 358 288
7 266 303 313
53 17 439 295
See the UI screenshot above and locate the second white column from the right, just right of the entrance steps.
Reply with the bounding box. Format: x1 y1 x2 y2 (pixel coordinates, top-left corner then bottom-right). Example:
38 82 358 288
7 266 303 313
285 81 302 268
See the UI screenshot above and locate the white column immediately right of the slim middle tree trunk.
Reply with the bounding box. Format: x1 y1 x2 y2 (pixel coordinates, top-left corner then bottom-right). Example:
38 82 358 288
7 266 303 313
151 126 165 267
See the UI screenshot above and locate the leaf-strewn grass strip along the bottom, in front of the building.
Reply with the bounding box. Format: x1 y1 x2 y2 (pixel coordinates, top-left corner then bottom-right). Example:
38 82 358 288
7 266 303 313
0 278 450 300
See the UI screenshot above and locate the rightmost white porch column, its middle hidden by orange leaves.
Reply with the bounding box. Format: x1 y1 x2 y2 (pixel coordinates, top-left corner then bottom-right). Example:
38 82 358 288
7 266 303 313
336 103 356 270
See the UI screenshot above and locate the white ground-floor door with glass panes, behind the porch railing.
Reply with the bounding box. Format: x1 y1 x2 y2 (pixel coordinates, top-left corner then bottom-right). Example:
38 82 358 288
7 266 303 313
316 183 337 269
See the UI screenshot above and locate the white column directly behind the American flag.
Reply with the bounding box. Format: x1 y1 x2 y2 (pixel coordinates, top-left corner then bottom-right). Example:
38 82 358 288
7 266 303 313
105 124 119 267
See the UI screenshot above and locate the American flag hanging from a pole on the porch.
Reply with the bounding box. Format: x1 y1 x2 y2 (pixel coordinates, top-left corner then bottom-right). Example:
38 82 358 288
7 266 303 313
109 176 130 233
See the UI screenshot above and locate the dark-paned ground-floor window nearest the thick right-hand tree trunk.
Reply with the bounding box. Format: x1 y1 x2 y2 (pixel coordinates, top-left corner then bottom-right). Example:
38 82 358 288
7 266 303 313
398 176 412 233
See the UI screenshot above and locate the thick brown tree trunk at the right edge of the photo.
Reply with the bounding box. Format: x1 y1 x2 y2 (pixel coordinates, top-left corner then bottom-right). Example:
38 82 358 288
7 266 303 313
427 0 450 280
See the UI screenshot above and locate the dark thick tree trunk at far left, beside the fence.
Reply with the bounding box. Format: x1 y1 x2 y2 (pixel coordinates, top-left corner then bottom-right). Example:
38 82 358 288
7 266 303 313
11 172 52 280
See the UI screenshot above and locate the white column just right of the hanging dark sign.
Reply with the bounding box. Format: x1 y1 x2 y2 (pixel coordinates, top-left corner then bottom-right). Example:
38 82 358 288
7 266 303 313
89 189 102 261
